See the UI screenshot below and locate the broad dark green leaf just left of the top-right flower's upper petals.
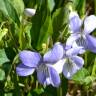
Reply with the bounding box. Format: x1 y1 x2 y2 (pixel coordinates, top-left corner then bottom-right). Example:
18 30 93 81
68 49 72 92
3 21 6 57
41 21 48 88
52 7 68 42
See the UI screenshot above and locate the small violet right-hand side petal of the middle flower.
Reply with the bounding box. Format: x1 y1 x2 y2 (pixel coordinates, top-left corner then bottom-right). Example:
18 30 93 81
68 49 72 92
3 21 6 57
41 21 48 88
71 56 84 69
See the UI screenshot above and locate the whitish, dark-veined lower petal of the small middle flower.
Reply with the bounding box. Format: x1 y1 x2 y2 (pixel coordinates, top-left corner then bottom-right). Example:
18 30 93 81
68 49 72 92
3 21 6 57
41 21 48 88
63 61 78 79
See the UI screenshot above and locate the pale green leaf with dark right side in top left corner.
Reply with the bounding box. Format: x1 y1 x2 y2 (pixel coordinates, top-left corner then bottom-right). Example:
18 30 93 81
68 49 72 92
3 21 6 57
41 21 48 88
0 0 20 26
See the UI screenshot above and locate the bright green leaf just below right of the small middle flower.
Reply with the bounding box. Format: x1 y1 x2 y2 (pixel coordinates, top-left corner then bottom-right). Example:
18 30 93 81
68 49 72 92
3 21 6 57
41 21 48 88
72 68 89 84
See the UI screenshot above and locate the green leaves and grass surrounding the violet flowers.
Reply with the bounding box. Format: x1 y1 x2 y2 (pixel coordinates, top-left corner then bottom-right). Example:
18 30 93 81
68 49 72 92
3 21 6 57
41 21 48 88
0 0 96 96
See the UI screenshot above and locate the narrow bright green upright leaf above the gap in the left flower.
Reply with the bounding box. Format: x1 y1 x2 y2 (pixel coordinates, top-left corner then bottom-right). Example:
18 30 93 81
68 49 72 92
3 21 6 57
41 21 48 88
37 13 53 49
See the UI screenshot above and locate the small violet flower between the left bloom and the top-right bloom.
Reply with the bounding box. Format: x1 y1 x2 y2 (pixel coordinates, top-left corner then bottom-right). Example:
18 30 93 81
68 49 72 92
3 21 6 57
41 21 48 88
62 47 84 79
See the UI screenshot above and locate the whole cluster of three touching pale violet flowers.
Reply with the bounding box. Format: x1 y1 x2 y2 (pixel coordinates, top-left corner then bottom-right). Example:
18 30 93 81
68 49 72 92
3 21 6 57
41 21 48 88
16 12 96 87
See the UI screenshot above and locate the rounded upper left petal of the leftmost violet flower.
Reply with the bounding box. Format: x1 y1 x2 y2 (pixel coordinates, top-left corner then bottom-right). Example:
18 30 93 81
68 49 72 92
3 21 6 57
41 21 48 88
19 50 41 67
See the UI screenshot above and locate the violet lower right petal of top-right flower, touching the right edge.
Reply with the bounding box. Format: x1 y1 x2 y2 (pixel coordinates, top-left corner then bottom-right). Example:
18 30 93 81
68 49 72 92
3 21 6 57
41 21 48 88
86 35 96 53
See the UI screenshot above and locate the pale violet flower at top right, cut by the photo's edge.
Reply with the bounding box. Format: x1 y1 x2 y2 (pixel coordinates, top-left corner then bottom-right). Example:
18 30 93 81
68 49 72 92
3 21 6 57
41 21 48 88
66 12 96 53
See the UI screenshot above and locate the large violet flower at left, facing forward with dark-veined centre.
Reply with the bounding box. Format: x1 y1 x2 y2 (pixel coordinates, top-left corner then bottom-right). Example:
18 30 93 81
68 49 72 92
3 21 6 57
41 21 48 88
16 43 63 87
